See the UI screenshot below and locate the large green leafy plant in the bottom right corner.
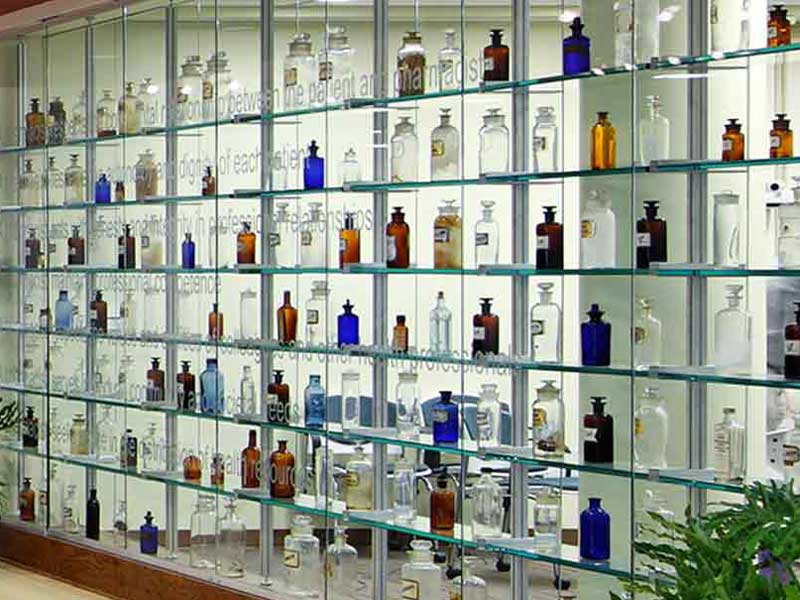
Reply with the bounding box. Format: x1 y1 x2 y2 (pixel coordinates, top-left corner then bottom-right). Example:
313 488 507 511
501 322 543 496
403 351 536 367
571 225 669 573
611 482 800 600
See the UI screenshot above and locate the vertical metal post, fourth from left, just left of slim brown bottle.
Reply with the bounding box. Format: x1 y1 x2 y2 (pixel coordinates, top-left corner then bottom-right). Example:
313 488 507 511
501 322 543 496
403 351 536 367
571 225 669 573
259 0 278 585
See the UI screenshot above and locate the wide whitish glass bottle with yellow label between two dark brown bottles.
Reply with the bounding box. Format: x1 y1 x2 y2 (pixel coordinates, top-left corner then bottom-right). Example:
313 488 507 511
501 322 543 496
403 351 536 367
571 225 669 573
581 190 617 269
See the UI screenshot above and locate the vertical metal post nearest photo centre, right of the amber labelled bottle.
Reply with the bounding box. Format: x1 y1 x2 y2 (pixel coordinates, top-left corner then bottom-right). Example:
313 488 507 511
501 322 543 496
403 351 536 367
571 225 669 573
372 0 389 600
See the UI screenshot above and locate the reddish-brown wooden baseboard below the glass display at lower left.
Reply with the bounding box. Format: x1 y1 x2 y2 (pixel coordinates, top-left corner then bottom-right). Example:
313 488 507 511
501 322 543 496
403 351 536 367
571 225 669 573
0 521 279 600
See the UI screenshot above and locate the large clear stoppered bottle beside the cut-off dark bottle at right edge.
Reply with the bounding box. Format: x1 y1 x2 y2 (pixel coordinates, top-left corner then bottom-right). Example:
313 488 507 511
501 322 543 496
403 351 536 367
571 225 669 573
714 284 752 373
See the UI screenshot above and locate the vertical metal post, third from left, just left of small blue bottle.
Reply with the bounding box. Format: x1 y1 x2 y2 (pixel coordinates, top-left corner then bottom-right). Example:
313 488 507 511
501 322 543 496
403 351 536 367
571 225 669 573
164 1 178 558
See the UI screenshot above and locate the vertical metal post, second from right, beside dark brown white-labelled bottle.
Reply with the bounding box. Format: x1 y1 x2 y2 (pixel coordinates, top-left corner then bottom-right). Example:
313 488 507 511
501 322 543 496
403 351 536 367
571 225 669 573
511 0 530 599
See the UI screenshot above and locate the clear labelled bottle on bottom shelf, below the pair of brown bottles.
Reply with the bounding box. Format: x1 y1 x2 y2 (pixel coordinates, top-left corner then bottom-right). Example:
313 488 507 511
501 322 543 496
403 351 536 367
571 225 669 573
283 515 322 596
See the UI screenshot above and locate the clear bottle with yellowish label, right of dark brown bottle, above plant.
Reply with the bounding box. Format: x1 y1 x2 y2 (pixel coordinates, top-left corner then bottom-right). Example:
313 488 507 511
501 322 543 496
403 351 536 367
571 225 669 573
633 386 669 469
